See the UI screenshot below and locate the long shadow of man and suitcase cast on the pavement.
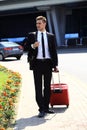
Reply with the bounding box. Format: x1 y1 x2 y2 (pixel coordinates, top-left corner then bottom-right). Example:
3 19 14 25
14 107 67 130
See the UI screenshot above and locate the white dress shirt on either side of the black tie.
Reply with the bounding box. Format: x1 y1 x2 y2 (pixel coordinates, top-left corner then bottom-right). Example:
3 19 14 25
37 31 50 59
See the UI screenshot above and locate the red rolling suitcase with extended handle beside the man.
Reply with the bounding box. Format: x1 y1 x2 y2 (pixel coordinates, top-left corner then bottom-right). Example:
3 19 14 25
50 72 69 107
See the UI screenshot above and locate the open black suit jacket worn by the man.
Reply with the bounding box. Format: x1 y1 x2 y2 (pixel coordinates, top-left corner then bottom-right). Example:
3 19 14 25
28 32 58 69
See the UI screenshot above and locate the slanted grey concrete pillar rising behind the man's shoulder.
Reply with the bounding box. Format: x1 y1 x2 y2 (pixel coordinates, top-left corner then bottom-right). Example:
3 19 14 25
51 7 66 46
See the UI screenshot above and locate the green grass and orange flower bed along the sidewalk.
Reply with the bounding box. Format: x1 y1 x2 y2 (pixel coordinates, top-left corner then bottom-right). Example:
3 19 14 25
0 65 21 130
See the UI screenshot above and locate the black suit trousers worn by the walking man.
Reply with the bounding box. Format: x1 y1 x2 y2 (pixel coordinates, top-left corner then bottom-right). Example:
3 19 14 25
33 59 52 111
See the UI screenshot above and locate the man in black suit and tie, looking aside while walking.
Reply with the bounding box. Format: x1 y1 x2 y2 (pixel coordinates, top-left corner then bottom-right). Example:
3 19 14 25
28 16 58 117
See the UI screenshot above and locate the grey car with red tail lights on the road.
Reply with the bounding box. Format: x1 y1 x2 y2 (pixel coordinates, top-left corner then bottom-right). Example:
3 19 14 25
0 41 23 61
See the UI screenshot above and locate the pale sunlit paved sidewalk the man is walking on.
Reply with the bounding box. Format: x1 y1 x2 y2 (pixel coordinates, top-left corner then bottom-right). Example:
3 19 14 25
14 60 87 130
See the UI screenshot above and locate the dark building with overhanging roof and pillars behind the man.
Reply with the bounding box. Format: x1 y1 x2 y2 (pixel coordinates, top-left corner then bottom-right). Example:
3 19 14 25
0 0 87 47
